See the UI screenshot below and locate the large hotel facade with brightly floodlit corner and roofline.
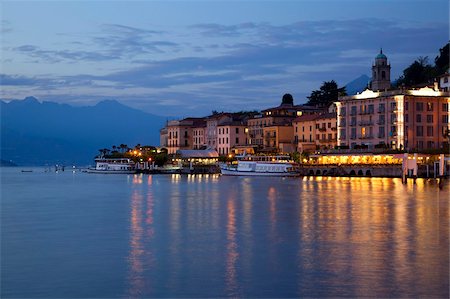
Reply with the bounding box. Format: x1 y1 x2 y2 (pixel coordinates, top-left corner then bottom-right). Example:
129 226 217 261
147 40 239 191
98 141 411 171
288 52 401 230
336 87 450 150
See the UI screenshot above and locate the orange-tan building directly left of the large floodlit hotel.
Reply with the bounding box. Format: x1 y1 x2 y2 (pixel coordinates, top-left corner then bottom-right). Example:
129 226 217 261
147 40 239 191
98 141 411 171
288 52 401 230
293 113 337 153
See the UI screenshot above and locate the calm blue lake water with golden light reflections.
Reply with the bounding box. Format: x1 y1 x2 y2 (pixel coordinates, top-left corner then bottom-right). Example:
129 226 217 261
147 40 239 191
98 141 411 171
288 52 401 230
0 168 449 298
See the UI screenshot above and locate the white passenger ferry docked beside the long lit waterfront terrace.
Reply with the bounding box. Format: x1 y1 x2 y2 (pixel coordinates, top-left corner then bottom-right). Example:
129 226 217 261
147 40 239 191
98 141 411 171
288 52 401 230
220 156 300 176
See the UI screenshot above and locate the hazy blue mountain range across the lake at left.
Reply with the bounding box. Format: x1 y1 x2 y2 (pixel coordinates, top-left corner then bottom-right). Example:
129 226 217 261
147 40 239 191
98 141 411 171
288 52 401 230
0 97 166 165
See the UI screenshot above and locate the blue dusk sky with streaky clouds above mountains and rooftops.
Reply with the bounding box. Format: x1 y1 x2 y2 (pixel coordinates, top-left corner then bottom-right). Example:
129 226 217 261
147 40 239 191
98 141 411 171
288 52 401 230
0 0 449 117
